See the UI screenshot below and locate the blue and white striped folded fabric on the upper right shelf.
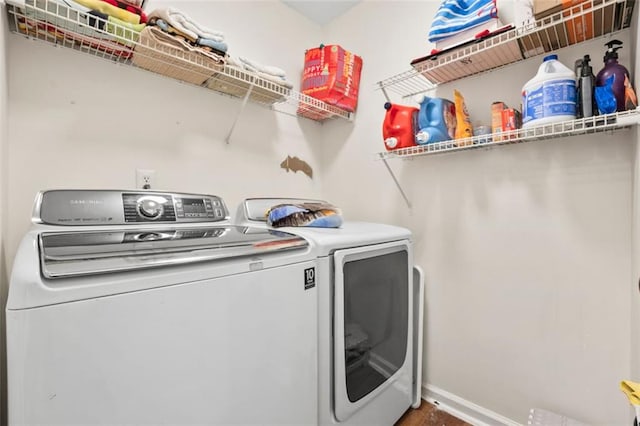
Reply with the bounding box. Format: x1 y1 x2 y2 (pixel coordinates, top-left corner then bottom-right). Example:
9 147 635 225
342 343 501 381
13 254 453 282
429 0 498 42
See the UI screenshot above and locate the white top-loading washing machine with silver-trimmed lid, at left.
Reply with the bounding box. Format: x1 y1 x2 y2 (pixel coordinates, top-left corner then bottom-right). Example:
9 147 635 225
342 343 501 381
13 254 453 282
6 190 318 425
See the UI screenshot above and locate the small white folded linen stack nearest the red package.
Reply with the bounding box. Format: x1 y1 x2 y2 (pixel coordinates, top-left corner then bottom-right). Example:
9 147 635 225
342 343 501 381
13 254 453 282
207 56 293 104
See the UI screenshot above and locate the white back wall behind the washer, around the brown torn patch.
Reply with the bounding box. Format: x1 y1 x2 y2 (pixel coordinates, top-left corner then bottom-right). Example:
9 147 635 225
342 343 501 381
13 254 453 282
6 1 322 270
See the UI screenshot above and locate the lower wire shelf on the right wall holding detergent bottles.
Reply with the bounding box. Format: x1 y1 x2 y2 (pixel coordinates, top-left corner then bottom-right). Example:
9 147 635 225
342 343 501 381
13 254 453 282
376 108 640 160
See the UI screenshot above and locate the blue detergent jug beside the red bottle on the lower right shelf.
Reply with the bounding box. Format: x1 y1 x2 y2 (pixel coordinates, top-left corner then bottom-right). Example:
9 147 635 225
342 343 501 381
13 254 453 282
416 95 456 145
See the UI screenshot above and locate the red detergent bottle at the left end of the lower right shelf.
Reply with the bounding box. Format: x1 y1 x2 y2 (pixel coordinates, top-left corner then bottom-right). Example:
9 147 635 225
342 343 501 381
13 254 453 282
382 102 420 151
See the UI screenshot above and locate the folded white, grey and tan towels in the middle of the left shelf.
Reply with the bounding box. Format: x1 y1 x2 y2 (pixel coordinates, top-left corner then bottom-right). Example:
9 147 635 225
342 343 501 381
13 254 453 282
132 7 227 85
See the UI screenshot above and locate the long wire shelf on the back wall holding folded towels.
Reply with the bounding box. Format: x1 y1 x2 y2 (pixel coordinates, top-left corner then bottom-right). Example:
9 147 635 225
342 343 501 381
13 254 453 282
6 0 352 121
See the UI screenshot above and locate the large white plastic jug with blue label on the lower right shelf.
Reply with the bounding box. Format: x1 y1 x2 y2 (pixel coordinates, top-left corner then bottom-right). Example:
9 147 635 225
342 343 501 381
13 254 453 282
522 55 576 127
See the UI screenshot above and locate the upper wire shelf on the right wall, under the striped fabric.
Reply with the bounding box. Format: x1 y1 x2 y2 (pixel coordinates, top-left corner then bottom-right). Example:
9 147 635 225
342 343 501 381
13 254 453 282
378 0 635 97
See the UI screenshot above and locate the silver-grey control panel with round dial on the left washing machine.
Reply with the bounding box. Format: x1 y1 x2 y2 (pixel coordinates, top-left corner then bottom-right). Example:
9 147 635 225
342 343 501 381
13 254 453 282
33 190 229 226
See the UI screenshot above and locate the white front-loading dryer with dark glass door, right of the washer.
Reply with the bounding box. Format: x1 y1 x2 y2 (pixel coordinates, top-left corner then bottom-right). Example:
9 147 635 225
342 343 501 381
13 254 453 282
234 198 424 426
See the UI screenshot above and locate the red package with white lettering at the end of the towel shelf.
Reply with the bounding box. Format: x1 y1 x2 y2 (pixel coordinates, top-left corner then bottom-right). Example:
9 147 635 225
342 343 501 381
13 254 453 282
301 45 362 112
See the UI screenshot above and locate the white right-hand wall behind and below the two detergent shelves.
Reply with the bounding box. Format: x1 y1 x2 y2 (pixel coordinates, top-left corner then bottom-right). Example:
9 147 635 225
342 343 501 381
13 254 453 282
323 1 637 425
